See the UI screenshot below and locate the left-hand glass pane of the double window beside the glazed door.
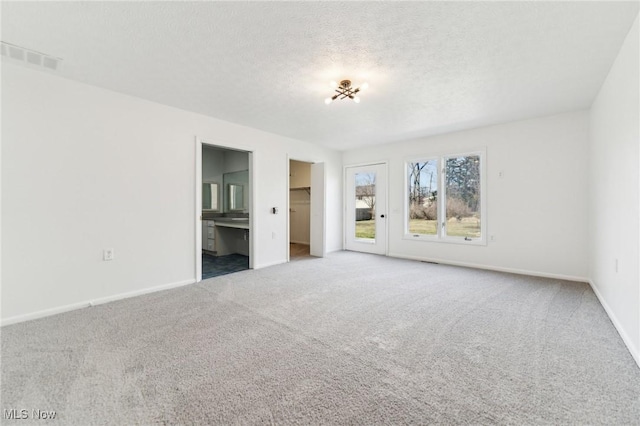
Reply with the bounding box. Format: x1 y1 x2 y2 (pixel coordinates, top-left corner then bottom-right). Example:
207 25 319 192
407 160 438 235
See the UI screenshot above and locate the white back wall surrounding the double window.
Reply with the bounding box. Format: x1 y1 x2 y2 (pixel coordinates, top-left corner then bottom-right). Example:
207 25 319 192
343 111 588 280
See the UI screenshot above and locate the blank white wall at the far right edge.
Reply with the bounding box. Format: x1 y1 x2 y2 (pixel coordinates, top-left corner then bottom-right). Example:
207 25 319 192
589 18 640 364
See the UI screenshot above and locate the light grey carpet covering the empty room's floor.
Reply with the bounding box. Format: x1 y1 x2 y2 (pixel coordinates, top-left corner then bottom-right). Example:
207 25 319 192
0 252 640 425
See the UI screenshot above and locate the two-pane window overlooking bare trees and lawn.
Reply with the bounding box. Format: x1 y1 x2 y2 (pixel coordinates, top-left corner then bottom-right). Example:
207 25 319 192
405 152 486 243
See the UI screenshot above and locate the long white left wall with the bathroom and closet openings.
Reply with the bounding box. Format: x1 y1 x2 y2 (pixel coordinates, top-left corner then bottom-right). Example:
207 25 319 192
1 63 342 324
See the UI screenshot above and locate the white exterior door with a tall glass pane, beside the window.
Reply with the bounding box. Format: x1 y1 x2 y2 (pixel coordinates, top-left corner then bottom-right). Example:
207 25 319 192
345 163 387 255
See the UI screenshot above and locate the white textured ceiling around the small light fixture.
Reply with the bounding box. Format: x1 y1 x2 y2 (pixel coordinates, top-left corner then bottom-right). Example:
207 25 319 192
2 1 638 150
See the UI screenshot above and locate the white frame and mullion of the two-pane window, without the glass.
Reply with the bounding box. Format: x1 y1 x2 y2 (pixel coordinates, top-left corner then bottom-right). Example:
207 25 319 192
403 148 488 246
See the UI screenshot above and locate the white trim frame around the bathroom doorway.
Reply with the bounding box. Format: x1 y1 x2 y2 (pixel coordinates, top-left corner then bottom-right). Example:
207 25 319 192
193 136 257 282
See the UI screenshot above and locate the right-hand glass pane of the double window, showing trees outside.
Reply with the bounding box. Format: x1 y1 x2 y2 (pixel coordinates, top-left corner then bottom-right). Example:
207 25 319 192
445 155 481 238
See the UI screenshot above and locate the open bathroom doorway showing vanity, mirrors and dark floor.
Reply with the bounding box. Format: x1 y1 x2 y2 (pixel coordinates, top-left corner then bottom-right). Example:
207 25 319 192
195 140 254 281
